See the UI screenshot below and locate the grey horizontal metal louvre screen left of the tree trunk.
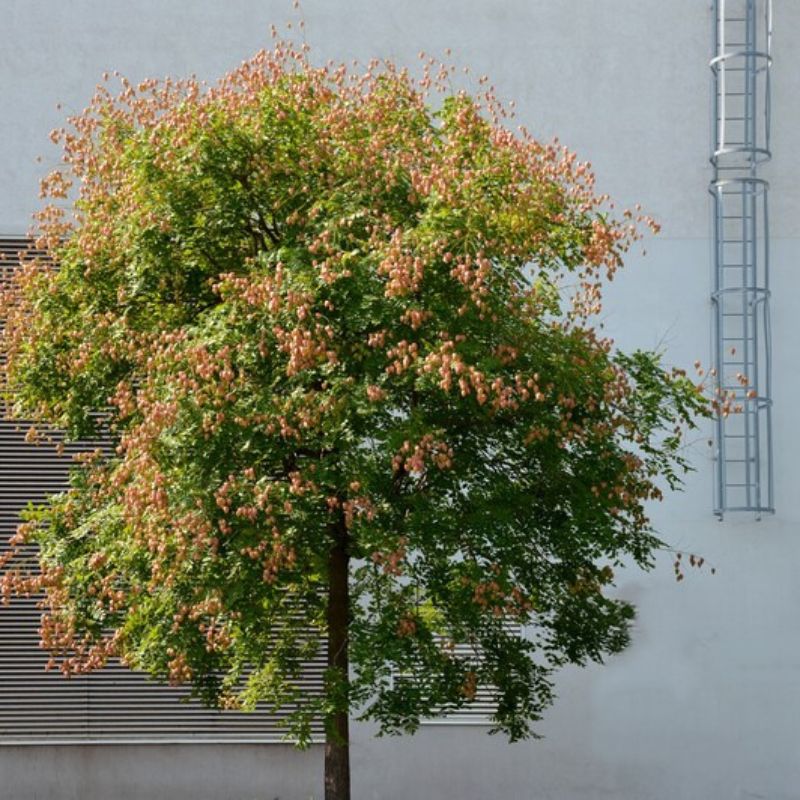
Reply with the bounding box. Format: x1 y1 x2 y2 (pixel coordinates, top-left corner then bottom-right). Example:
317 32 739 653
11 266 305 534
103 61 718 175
0 238 325 745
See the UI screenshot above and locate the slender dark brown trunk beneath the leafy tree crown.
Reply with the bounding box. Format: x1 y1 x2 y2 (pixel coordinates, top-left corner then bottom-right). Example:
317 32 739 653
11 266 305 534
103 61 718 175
325 515 350 800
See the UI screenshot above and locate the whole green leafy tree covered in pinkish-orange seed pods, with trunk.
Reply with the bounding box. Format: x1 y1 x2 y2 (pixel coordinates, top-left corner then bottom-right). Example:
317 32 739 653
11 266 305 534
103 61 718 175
0 43 703 800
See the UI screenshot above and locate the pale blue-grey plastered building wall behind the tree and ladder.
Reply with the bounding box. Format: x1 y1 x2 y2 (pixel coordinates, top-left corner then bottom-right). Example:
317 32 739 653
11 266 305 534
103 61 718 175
0 0 800 800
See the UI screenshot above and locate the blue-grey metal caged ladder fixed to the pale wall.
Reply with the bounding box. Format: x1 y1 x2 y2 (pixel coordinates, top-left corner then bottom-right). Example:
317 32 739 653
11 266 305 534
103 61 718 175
709 0 774 519
